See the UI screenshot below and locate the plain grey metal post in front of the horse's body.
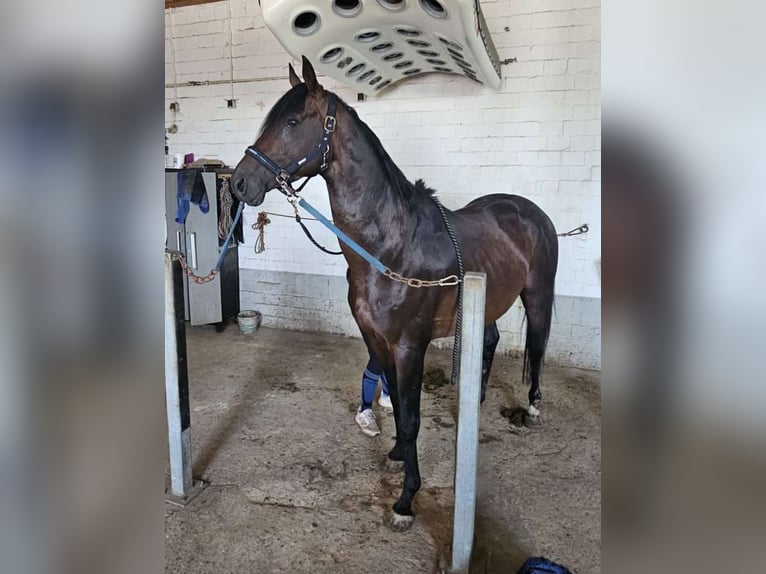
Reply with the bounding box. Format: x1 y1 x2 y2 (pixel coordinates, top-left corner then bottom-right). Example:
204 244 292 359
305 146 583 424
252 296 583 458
452 272 487 574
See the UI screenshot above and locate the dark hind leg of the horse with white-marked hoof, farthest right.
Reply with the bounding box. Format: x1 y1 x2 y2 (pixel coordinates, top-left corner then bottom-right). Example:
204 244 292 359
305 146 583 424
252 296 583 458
521 277 553 420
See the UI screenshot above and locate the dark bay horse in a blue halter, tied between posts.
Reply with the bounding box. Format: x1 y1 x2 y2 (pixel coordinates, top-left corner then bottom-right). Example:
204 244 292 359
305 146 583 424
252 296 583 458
231 57 558 531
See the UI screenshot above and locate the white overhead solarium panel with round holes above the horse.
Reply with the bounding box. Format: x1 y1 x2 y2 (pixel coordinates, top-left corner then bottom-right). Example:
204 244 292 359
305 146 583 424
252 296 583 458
261 0 508 95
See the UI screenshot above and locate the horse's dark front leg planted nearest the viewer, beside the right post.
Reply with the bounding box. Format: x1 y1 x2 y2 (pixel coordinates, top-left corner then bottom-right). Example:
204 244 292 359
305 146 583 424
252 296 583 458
389 346 425 532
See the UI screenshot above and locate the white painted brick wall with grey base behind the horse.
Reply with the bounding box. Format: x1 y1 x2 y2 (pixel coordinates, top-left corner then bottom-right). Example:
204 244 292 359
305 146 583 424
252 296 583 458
165 0 601 368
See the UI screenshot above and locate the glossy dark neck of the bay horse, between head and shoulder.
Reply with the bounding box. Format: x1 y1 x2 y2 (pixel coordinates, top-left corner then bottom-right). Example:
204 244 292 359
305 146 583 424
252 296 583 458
325 105 424 249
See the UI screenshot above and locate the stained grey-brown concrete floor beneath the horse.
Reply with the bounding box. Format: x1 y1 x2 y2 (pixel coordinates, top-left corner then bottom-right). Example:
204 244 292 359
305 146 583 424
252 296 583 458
165 325 601 574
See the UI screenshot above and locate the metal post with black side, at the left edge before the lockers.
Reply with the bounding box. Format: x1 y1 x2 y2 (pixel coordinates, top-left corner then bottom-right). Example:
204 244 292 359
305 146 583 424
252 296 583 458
165 253 192 497
